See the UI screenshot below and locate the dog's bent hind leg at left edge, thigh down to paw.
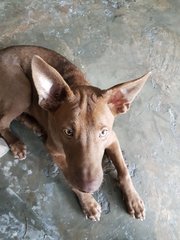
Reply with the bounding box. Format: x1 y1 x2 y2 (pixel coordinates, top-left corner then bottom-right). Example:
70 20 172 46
0 66 31 160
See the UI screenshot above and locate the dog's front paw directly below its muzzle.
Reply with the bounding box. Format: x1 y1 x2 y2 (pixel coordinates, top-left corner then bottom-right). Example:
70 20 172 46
83 198 101 221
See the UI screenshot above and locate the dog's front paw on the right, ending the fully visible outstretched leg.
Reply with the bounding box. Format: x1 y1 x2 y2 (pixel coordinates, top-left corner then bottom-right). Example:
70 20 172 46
126 191 145 221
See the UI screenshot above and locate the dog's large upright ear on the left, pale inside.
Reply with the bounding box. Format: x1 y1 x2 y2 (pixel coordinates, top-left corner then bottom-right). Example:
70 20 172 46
31 55 73 111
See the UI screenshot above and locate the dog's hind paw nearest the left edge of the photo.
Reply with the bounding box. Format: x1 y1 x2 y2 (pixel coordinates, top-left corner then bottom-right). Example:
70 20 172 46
10 141 26 160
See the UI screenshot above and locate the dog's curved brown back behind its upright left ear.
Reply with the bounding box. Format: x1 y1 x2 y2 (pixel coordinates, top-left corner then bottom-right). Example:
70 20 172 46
0 46 87 86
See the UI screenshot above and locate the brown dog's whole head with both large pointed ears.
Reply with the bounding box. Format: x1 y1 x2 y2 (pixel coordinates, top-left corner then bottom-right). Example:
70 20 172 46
32 56 149 192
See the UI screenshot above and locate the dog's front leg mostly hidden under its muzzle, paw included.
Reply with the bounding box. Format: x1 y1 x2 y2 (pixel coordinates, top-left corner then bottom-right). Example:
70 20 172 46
72 188 101 221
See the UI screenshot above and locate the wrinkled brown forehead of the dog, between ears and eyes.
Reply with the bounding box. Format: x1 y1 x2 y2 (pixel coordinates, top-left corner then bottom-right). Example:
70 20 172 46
56 86 112 125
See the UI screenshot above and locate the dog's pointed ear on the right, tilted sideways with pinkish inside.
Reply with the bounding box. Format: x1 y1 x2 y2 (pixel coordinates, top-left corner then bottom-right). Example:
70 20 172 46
105 72 151 115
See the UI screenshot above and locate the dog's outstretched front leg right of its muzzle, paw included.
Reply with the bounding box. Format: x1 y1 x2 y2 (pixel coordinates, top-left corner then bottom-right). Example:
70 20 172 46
106 133 145 220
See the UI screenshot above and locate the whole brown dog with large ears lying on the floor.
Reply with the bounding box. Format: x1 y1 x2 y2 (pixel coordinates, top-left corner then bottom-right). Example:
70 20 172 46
0 46 150 221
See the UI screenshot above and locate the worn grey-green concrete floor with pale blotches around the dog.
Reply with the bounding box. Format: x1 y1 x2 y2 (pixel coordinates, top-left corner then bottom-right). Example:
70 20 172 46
0 0 180 240
